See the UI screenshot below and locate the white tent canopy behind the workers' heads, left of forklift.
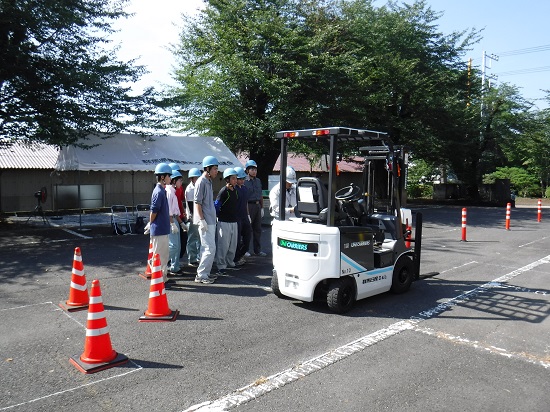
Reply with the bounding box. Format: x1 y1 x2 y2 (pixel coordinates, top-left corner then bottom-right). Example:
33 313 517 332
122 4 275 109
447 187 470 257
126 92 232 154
56 134 242 172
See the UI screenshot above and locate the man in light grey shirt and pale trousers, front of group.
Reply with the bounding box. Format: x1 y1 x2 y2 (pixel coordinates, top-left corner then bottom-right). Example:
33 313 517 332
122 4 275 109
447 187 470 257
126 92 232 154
193 156 218 283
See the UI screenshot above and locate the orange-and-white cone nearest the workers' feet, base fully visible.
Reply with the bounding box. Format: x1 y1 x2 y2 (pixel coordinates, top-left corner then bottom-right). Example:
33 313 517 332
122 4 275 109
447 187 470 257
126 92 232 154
139 253 179 322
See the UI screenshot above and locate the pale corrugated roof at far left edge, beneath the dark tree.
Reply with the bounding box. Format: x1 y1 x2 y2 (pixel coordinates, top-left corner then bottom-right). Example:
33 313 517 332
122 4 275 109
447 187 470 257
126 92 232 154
0 139 59 169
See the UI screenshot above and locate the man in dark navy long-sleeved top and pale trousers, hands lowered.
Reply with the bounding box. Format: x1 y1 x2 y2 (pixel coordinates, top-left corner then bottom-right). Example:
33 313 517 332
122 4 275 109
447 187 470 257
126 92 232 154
214 167 239 275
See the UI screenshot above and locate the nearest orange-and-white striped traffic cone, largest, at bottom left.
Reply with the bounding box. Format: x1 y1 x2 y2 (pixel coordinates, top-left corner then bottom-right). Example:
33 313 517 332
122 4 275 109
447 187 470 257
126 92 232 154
69 279 128 373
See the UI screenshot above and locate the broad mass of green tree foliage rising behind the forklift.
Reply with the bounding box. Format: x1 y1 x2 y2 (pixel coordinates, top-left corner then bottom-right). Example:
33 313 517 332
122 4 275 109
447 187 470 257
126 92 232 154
168 0 484 187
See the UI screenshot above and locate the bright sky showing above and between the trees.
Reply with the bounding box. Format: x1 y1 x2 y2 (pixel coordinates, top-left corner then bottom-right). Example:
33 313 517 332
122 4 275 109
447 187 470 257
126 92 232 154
112 0 550 109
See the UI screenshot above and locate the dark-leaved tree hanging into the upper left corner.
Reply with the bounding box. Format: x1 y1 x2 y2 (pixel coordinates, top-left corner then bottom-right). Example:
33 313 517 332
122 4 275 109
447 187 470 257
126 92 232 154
0 0 162 145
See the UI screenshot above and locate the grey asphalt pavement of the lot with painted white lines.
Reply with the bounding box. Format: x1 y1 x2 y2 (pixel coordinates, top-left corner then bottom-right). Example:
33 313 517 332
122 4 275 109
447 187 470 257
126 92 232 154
0 206 550 411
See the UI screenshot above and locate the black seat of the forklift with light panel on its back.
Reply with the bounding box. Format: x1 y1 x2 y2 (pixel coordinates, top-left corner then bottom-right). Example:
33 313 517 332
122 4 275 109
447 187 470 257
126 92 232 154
296 177 328 223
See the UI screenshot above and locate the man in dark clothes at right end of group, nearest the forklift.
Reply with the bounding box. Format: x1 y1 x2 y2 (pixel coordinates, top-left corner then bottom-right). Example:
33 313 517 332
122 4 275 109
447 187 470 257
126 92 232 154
244 160 267 257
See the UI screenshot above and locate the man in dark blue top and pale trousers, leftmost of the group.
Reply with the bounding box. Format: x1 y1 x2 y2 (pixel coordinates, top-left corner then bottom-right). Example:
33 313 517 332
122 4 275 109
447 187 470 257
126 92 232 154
149 163 172 284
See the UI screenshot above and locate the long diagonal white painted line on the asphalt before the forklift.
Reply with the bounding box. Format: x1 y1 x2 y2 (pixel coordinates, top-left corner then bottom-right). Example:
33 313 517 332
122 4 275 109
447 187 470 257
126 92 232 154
184 255 550 412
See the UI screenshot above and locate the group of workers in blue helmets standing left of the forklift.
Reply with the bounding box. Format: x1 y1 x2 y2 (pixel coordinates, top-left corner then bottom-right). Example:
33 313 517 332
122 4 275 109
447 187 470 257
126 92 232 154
147 156 274 288
